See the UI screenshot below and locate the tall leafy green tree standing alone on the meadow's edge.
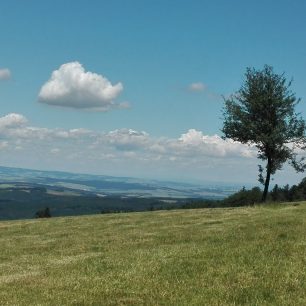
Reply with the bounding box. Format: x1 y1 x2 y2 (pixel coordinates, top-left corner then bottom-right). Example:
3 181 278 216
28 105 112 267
222 65 306 202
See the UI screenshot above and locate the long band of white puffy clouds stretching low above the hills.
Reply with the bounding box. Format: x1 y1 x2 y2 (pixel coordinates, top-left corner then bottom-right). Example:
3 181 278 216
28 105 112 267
0 113 256 160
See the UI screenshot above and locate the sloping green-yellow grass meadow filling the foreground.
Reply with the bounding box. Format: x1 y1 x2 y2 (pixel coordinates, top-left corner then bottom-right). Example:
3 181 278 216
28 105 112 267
0 203 306 305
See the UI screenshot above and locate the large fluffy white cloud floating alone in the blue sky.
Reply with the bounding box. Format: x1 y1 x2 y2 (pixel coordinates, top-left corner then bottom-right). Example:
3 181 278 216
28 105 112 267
38 62 128 111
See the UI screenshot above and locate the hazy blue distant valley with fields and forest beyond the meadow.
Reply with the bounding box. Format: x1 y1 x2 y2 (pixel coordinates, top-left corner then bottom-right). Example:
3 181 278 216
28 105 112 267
0 167 238 220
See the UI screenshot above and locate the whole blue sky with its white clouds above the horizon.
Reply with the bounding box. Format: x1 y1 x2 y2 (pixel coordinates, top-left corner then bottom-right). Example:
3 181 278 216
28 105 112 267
0 0 306 184
